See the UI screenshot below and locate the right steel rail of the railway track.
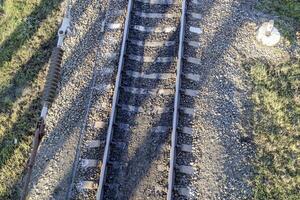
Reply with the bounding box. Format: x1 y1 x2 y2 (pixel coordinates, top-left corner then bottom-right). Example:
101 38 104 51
167 0 186 200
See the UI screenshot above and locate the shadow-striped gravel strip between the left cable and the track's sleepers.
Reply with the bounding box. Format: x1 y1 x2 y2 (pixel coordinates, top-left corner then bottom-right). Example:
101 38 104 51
25 0 122 199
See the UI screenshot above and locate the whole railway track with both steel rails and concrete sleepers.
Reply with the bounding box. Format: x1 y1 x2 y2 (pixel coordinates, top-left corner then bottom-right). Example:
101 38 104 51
69 0 201 199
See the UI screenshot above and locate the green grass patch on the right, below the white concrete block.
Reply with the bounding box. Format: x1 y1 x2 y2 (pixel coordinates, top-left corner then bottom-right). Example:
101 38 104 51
250 60 300 200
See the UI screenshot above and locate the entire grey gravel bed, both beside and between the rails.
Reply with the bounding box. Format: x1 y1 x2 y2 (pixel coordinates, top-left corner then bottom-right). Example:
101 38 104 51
24 0 293 200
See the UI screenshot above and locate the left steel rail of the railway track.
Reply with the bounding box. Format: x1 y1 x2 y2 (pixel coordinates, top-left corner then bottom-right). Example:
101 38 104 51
96 0 133 200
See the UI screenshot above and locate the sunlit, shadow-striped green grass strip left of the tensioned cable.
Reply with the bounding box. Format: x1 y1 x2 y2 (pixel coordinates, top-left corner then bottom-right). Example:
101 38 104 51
0 0 62 199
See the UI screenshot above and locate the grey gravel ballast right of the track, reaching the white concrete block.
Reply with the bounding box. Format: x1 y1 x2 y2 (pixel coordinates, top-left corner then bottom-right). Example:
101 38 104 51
176 0 289 200
